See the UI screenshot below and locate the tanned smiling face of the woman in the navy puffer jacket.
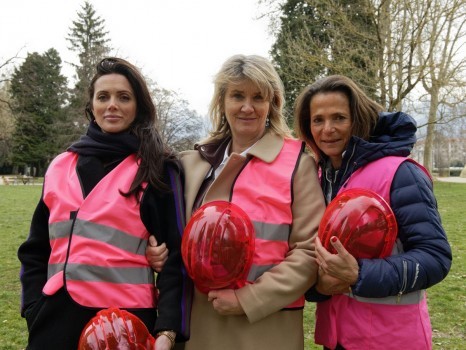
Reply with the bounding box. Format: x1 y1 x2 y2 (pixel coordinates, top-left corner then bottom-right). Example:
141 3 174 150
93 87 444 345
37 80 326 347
310 92 352 169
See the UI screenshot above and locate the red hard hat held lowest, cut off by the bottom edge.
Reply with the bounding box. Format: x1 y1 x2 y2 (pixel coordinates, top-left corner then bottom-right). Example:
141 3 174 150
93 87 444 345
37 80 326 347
78 307 155 350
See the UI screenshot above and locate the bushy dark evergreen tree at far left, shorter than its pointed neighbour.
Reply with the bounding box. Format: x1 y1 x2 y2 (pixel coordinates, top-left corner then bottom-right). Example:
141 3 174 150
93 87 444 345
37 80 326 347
10 49 67 174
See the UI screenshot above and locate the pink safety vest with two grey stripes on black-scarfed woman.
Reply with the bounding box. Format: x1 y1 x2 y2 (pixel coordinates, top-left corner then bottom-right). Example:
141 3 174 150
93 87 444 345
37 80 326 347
43 152 156 308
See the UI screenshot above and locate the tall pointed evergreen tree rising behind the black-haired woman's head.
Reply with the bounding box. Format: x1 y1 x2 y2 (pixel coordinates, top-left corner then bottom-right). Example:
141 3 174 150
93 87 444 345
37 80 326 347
64 1 110 143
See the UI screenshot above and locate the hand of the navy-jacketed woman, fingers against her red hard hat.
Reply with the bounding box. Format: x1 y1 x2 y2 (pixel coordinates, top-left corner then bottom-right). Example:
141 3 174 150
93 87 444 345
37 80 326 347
316 236 359 289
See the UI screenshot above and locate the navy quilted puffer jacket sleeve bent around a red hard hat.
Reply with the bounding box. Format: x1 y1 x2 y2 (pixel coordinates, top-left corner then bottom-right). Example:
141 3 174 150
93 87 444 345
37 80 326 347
353 161 452 298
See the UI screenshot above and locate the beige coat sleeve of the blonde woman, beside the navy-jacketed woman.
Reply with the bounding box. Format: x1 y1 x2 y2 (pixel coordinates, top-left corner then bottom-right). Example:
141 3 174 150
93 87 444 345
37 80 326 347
236 154 325 322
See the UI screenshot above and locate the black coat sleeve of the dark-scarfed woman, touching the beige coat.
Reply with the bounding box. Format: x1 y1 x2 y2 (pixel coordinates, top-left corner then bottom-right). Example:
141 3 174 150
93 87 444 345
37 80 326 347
141 163 192 341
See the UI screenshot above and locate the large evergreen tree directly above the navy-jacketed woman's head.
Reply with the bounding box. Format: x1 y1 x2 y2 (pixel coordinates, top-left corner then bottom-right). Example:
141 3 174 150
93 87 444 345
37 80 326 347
271 0 378 110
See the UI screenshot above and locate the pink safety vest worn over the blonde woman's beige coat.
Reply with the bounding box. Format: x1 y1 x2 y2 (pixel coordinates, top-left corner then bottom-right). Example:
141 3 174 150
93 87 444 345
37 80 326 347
231 139 304 308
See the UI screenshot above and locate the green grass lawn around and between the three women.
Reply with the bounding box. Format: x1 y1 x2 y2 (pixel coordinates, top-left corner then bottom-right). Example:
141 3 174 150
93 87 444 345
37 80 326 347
0 182 466 350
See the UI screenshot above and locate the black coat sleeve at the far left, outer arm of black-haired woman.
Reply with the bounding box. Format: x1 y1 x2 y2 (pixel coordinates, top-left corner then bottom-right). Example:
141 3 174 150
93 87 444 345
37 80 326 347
18 194 51 317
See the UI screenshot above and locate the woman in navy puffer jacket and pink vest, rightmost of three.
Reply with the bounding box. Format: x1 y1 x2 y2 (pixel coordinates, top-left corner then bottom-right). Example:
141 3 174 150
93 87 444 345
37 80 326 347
295 75 452 349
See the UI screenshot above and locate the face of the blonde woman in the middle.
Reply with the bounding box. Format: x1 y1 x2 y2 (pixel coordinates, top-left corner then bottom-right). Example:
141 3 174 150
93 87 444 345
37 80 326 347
225 80 270 152
